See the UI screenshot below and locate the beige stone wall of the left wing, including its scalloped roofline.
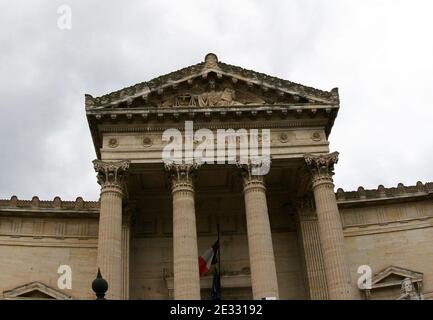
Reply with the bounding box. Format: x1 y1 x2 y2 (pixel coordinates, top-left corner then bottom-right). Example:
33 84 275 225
0 197 98 299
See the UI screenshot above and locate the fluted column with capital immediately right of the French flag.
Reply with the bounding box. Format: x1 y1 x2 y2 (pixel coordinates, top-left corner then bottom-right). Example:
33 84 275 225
238 163 279 300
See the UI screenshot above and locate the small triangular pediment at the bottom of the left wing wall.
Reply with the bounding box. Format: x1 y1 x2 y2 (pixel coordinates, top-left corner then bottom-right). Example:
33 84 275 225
3 281 72 300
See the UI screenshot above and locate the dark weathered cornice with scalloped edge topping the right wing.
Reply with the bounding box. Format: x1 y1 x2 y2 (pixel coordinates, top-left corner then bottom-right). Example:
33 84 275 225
336 181 433 207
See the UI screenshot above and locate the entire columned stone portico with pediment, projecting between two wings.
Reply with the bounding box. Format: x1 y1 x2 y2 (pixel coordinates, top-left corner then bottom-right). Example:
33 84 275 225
86 54 352 299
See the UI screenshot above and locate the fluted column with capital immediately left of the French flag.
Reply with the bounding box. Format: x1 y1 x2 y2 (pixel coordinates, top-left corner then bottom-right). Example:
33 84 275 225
165 163 200 300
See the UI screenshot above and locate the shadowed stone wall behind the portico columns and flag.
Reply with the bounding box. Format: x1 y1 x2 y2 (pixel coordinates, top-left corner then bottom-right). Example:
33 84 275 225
130 190 305 299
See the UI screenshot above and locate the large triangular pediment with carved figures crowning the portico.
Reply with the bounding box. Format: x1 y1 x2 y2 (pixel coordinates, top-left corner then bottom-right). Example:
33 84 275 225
86 54 339 109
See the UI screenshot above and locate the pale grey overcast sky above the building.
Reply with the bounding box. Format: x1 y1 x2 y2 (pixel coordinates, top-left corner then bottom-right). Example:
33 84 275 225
0 0 433 200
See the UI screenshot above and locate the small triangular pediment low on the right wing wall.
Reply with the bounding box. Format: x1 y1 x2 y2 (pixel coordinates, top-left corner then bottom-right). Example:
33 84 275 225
371 266 423 289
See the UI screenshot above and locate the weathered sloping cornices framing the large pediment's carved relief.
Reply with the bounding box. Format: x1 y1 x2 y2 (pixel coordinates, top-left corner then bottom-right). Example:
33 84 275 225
85 54 339 110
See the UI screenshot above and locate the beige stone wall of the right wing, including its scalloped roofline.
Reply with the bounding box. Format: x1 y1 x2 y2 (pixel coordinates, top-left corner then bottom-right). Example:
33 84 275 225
337 182 433 299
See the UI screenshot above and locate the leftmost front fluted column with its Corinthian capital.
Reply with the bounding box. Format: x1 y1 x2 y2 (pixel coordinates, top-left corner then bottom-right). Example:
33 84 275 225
93 160 129 299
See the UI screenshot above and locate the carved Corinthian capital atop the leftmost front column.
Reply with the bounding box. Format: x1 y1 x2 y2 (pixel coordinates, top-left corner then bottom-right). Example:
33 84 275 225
93 160 130 187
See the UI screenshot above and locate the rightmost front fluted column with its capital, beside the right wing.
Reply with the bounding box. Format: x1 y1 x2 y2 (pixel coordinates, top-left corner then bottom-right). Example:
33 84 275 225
304 152 354 300
